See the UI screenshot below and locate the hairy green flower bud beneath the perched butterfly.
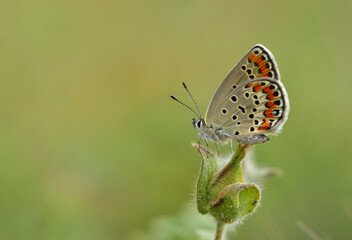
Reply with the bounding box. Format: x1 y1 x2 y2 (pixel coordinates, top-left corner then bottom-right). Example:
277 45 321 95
194 144 260 224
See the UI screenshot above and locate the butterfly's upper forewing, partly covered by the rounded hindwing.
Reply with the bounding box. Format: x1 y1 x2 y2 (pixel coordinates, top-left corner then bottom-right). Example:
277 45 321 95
205 44 280 126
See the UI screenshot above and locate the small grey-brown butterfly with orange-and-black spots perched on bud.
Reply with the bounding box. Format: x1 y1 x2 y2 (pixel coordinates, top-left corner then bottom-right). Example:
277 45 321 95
170 44 290 151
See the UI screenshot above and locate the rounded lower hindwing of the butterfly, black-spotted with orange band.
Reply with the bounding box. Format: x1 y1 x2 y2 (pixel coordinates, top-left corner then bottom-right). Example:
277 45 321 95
216 78 289 142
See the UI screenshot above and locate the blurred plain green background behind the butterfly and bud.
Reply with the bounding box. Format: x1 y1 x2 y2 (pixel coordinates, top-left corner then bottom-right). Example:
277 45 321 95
0 0 352 240
